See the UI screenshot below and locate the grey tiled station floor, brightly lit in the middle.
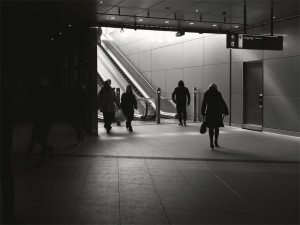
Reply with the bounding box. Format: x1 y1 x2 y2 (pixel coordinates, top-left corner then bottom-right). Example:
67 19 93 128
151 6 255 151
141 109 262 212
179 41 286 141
12 123 300 225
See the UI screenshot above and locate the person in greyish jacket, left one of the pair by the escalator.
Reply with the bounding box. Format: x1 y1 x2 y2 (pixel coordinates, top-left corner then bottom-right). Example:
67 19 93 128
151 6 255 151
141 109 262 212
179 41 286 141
98 80 120 134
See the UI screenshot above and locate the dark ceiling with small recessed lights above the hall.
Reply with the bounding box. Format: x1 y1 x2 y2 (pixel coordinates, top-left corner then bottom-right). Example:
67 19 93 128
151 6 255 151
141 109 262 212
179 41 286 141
2 0 300 37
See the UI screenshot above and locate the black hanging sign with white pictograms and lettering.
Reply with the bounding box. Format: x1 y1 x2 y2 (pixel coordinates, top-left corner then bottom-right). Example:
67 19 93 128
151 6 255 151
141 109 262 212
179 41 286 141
226 34 283 50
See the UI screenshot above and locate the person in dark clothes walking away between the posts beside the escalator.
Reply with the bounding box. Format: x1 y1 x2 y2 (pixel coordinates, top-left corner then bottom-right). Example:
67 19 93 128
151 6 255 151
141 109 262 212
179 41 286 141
172 80 191 126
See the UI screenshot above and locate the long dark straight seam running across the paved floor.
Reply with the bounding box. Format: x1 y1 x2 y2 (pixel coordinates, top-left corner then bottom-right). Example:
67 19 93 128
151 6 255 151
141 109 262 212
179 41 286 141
11 153 300 165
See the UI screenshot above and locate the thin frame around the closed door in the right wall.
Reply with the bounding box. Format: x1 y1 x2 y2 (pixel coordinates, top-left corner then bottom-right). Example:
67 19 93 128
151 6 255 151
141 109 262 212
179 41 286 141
242 60 264 131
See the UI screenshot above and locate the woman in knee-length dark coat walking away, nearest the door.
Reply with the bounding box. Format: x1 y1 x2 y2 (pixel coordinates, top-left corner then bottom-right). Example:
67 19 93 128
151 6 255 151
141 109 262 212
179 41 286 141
201 84 228 149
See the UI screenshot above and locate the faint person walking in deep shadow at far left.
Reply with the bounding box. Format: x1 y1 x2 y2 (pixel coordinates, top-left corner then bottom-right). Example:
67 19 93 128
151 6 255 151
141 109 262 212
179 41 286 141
26 76 53 164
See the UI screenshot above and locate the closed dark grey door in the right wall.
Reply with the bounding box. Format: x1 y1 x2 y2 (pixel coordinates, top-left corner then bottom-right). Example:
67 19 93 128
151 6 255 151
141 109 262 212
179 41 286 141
243 62 263 131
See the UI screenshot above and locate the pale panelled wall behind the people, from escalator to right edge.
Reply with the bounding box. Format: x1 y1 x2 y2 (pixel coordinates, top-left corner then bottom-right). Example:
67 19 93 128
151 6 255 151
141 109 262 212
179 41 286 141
103 19 300 132
